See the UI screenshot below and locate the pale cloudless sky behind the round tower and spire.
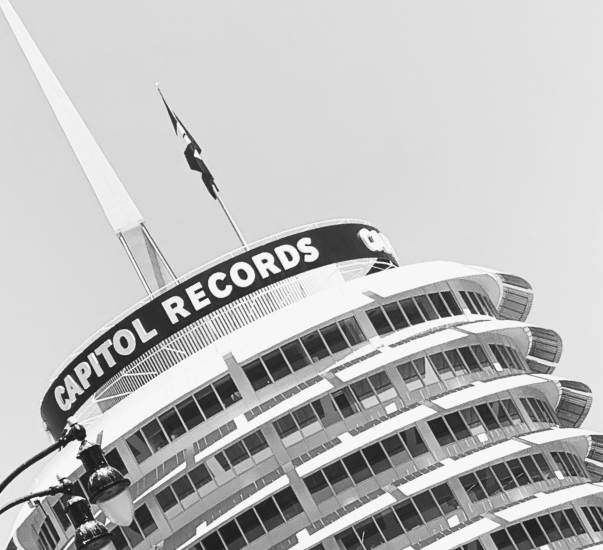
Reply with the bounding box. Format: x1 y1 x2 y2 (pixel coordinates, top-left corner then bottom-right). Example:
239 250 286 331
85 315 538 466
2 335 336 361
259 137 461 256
0 0 603 545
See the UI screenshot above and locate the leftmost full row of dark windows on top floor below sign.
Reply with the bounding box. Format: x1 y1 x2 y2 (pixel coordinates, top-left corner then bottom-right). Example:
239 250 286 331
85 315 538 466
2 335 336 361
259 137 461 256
126 375 241 464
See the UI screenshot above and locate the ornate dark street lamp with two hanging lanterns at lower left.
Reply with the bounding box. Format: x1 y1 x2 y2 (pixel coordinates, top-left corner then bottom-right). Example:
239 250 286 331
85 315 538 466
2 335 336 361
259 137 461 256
0 422 134 550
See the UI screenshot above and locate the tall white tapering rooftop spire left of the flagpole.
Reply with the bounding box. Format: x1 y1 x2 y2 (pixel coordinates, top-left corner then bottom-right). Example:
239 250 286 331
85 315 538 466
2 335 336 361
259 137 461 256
0 0 176 294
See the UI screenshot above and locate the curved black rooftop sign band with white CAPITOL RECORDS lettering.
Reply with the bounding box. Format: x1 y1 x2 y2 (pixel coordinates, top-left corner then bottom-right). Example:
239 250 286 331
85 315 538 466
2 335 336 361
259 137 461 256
41 223 397 437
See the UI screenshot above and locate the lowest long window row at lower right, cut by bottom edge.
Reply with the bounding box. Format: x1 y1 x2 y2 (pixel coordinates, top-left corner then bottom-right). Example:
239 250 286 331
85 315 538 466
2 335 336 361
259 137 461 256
490 508 585 550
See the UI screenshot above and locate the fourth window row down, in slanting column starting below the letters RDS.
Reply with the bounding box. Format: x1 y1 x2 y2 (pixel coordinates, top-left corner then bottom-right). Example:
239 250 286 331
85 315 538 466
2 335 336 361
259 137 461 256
335 483 459 550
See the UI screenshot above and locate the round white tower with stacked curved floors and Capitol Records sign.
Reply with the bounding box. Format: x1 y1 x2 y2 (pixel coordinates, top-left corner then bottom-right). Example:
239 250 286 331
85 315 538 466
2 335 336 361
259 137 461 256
10 220 603 550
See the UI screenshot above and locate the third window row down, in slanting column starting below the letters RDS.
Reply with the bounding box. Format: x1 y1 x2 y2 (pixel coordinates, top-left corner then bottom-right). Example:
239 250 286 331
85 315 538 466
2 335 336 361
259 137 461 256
304 427 429 503
